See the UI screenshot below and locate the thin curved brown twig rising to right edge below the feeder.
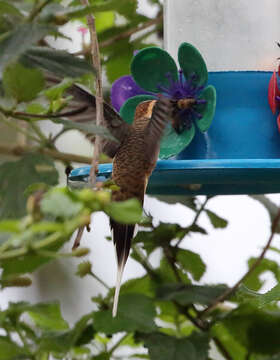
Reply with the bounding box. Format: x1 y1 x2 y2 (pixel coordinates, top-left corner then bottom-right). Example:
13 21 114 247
200 209 280 317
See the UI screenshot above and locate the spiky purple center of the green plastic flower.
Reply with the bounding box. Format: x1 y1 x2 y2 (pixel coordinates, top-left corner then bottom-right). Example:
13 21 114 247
158 69 207 133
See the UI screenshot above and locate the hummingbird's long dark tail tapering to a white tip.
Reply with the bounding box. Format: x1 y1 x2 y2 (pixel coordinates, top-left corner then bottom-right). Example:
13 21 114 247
110 219 135 317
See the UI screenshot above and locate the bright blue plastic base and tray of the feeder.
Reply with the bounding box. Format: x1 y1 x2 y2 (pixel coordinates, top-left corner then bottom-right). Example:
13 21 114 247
69 71 280 195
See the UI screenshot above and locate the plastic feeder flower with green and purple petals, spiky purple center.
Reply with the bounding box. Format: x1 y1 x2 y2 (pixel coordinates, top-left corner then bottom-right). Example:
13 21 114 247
111 43 216 159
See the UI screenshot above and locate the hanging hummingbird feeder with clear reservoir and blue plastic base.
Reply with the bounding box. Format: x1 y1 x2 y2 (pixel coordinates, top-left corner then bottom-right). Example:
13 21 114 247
69 0 280 195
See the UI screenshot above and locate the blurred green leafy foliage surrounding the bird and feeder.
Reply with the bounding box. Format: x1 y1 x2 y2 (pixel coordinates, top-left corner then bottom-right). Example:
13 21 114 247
0 0 280 360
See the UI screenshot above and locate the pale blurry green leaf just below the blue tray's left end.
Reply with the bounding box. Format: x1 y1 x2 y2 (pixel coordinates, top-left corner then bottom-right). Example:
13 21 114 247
41 188 82 218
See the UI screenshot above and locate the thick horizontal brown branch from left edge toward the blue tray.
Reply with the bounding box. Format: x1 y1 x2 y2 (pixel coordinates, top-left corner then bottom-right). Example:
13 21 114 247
0 144 91 164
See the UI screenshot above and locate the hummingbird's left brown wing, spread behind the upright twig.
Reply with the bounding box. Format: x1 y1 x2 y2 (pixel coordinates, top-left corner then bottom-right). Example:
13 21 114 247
46 75 130 157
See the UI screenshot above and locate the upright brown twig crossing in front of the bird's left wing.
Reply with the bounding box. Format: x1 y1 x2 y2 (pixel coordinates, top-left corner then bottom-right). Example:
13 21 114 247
80 0 104 187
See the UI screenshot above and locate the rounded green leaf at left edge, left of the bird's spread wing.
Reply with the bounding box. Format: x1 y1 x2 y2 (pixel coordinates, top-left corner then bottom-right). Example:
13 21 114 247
3 63 45 102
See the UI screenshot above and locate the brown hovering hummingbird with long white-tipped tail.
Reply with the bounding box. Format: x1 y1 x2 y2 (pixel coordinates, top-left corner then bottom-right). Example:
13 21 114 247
48 77 174 317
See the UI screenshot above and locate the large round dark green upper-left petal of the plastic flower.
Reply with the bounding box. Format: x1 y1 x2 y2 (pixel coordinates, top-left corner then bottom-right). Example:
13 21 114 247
131 47 178 93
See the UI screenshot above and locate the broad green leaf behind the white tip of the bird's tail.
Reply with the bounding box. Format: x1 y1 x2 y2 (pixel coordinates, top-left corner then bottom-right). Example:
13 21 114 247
94 293 156 334
